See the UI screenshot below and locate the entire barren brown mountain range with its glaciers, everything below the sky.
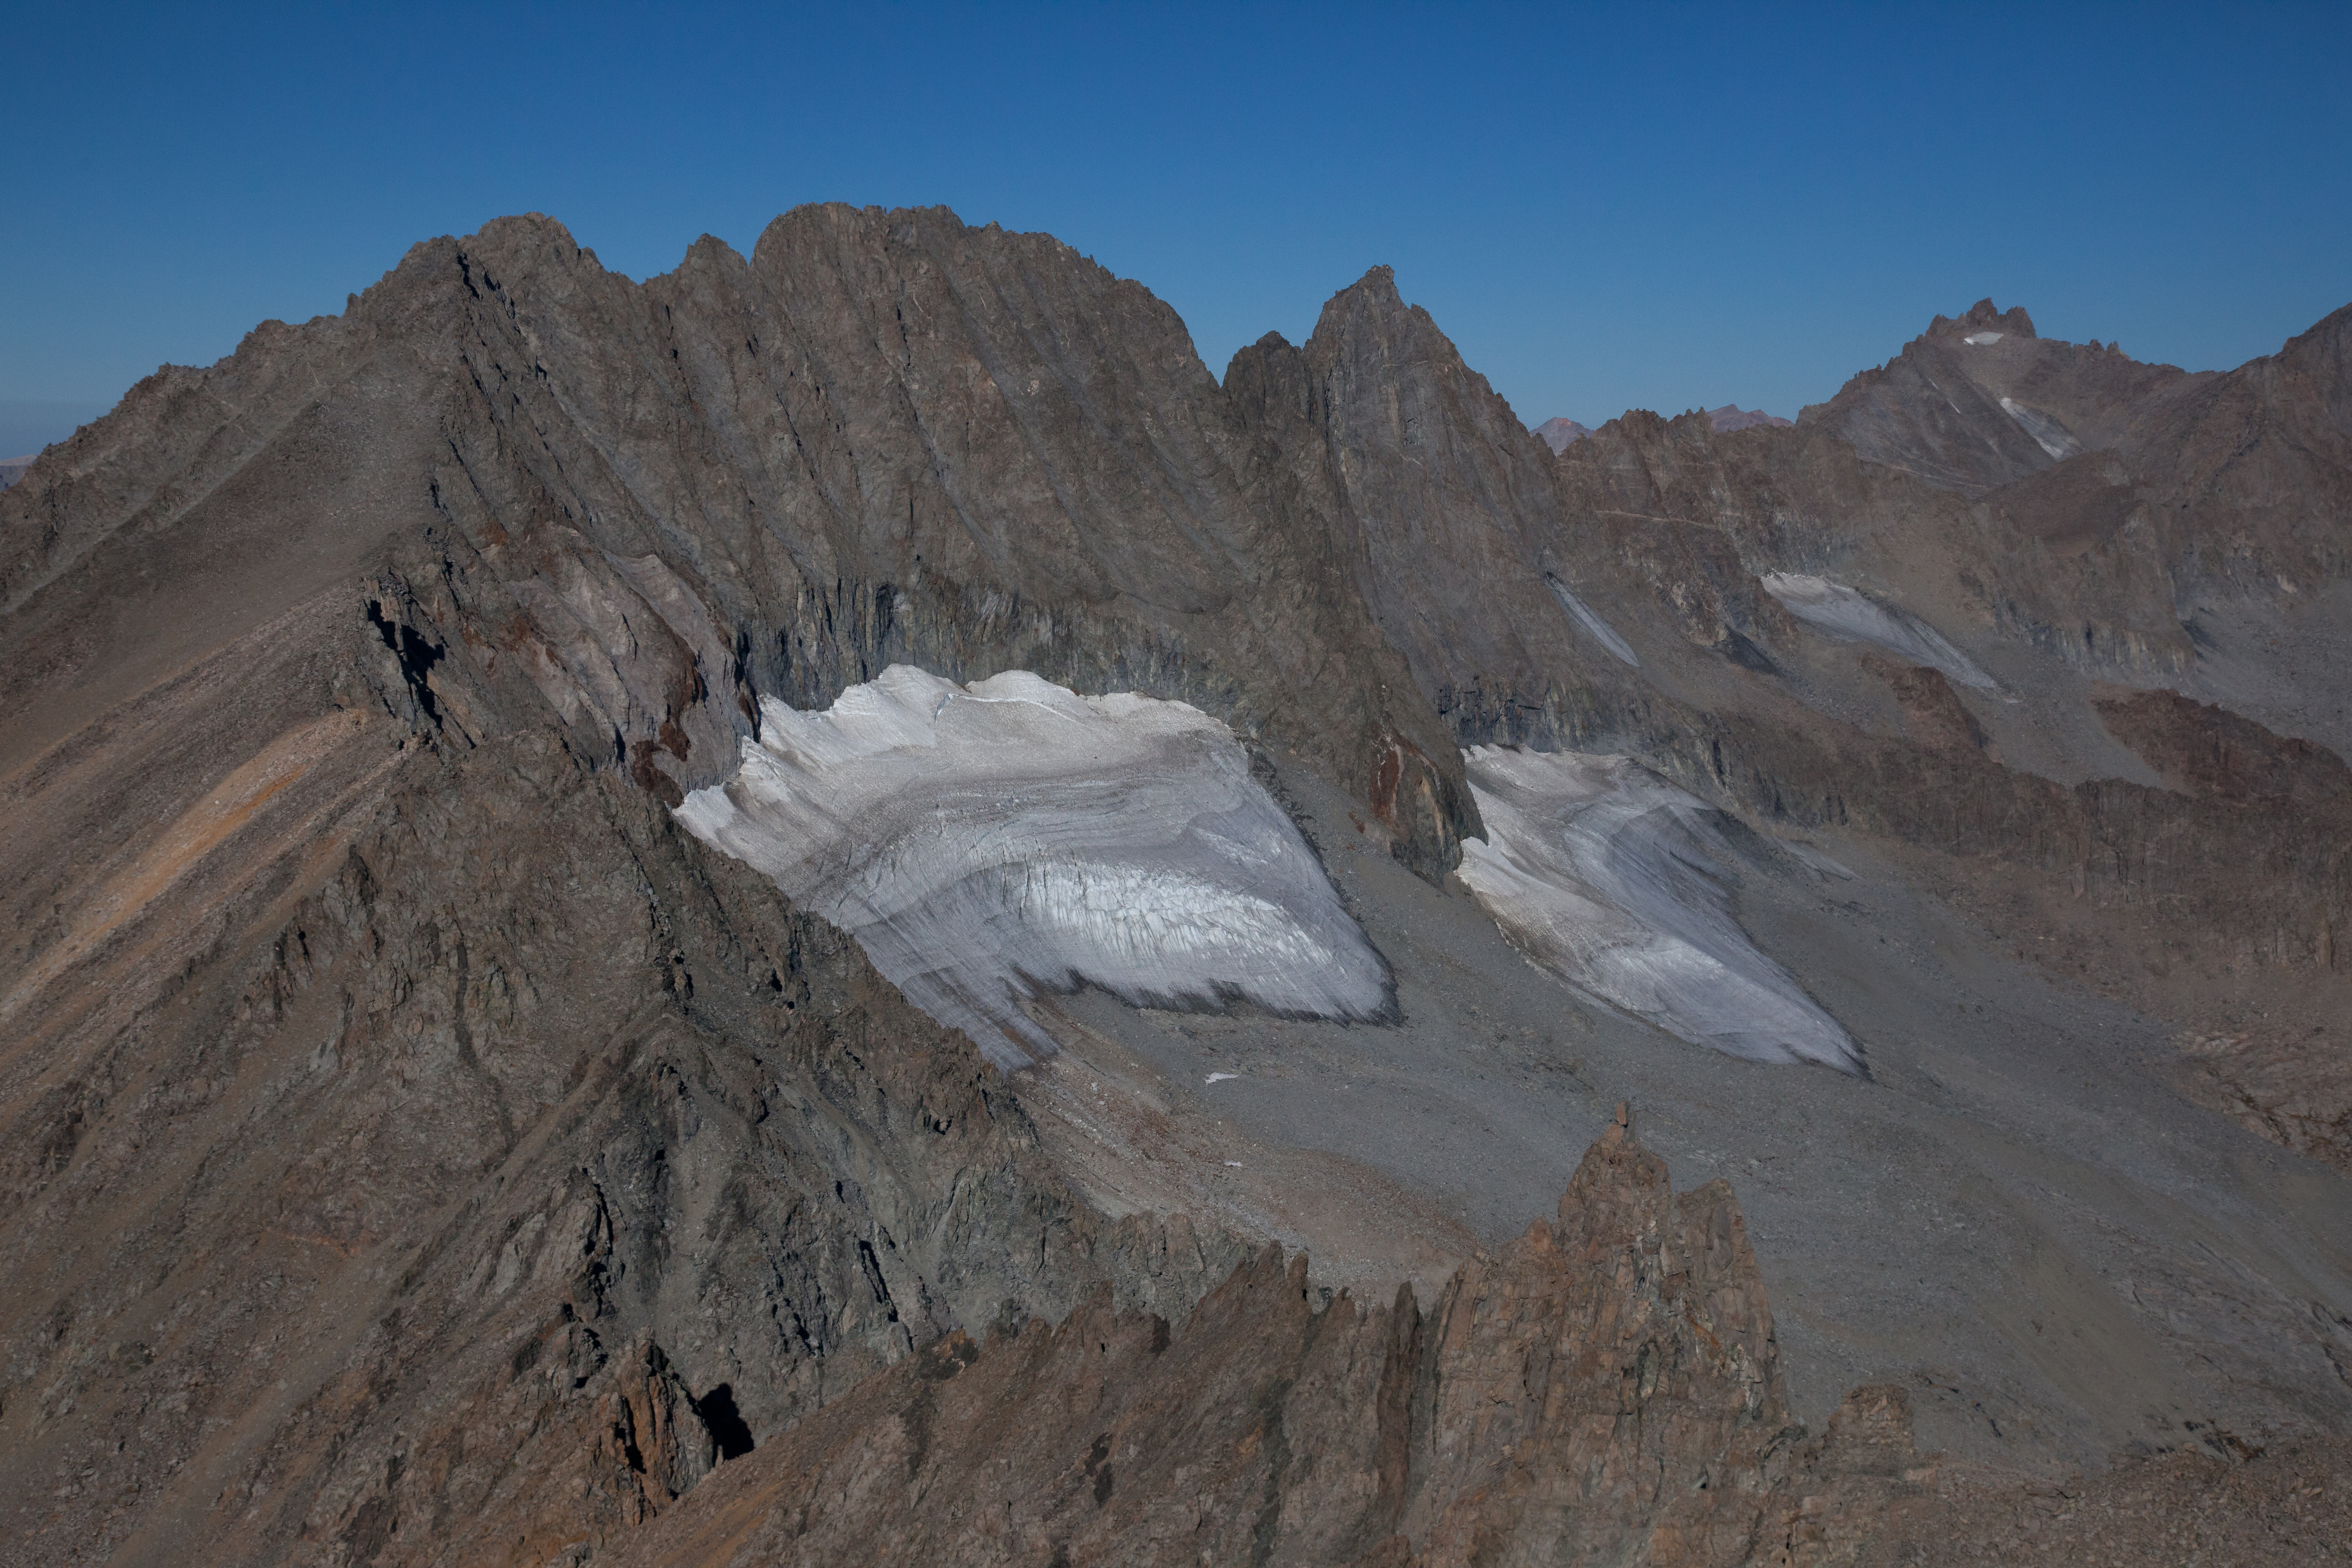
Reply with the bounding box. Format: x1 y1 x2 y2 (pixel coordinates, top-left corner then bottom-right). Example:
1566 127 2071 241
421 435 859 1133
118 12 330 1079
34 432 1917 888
0 207 2352 1563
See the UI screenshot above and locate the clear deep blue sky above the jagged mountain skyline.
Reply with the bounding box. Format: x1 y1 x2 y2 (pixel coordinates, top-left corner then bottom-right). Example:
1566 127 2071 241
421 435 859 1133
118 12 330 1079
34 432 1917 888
0 0 2352 456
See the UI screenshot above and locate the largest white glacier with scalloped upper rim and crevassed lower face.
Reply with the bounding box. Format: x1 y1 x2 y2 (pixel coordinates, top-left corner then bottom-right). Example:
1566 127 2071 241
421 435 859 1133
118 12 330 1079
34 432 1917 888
677 665 1395 1067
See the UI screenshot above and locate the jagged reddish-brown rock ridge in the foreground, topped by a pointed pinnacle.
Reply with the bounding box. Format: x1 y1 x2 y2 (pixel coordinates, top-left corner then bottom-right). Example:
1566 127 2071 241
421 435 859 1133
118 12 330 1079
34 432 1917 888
597 1112 1926 1568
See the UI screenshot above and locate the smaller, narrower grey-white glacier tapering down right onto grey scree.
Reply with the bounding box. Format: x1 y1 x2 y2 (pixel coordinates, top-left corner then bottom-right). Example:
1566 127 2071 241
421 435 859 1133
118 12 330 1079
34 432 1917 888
1461 745 1863 1072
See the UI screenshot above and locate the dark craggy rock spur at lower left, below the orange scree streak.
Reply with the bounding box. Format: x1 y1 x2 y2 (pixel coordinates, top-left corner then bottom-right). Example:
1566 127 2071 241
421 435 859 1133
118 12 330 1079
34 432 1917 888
0 733 1242 1563
